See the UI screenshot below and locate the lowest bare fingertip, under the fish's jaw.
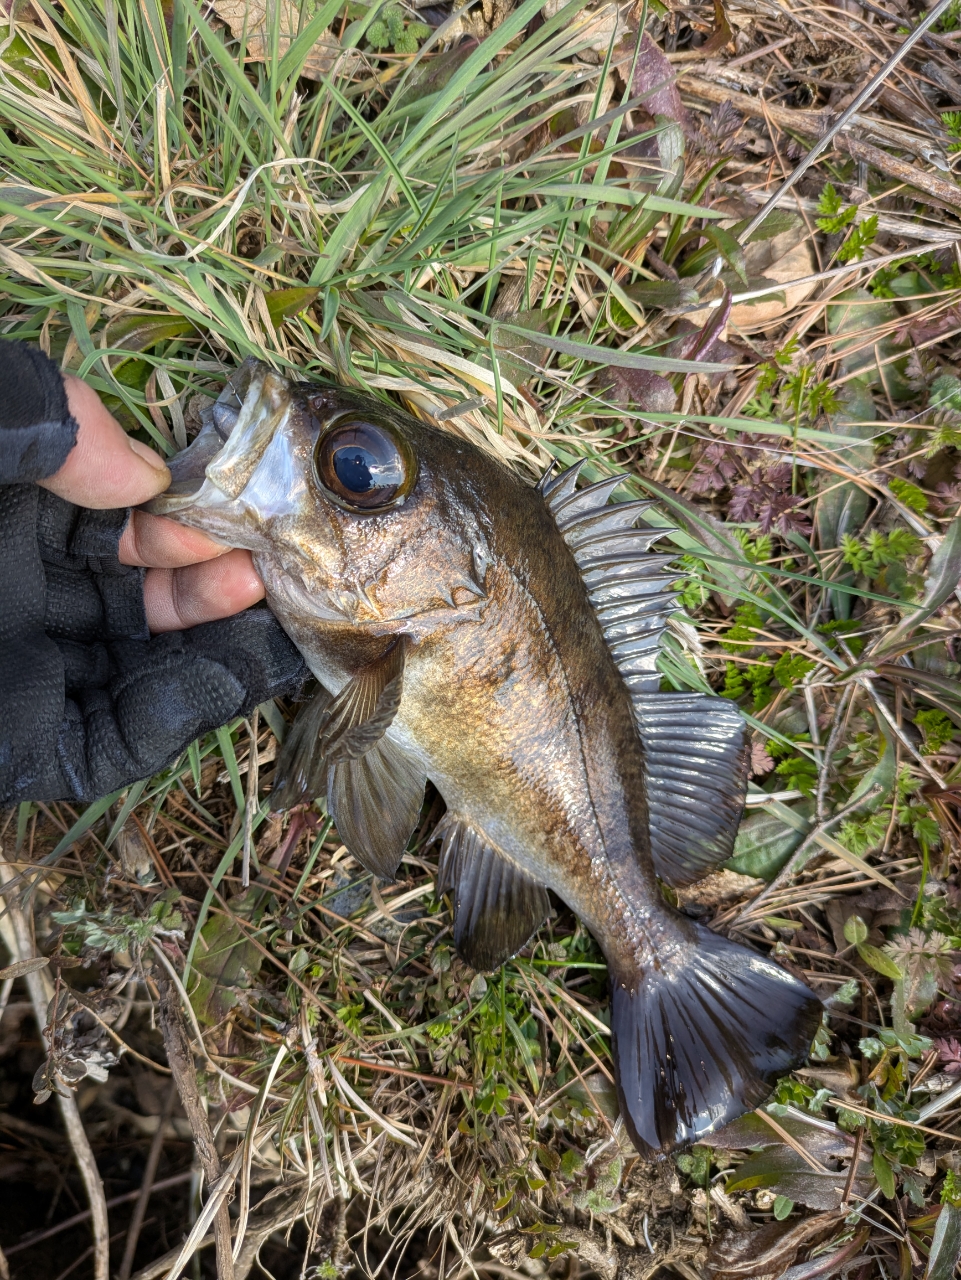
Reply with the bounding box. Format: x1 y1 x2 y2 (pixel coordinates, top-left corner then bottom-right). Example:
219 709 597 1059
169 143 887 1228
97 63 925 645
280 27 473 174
143 550 264 635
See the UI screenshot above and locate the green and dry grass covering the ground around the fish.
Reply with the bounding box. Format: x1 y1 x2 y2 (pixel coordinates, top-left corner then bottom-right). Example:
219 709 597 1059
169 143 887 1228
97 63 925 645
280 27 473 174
0 0 961 1280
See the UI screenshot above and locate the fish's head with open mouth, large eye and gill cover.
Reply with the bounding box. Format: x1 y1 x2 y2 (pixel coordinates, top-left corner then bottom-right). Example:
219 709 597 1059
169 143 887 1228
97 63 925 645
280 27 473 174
147 361 505 636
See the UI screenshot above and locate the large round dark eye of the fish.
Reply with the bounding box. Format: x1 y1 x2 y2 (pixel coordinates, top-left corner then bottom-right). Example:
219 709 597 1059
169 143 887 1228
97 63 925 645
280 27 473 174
314 416 417 512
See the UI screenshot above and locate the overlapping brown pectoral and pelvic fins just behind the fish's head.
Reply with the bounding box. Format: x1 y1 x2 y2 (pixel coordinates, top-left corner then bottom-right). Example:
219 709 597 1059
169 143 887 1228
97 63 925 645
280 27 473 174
270 639 427 879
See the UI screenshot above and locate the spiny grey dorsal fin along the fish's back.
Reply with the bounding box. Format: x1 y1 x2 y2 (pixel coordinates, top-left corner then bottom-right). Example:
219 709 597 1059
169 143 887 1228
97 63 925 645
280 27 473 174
541 463 749 884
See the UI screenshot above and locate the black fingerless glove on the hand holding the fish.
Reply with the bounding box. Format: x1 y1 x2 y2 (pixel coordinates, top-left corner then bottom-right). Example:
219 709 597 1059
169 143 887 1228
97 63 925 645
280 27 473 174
0 342 307 805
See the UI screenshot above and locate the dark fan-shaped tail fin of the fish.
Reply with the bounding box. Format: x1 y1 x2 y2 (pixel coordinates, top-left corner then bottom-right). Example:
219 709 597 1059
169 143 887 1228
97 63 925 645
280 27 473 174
610 925 822 1156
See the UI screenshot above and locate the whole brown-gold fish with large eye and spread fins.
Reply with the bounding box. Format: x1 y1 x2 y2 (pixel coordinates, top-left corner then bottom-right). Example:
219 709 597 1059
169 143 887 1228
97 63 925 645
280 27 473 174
148 360 822 1158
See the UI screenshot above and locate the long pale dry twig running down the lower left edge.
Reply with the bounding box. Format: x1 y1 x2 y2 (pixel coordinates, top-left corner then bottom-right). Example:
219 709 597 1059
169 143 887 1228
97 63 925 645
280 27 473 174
0 851 110 1280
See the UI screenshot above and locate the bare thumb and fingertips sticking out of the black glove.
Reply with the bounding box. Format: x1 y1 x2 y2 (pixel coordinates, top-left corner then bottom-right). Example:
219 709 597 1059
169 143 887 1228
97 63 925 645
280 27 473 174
40 374 264 635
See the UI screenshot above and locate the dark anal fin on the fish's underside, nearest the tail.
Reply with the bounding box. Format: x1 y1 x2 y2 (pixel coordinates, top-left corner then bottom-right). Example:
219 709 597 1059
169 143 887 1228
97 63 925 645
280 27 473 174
436 815 550 973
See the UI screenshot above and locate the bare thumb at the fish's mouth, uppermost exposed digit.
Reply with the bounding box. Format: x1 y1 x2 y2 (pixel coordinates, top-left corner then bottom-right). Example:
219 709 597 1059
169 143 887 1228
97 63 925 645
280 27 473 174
40 374 170 511
